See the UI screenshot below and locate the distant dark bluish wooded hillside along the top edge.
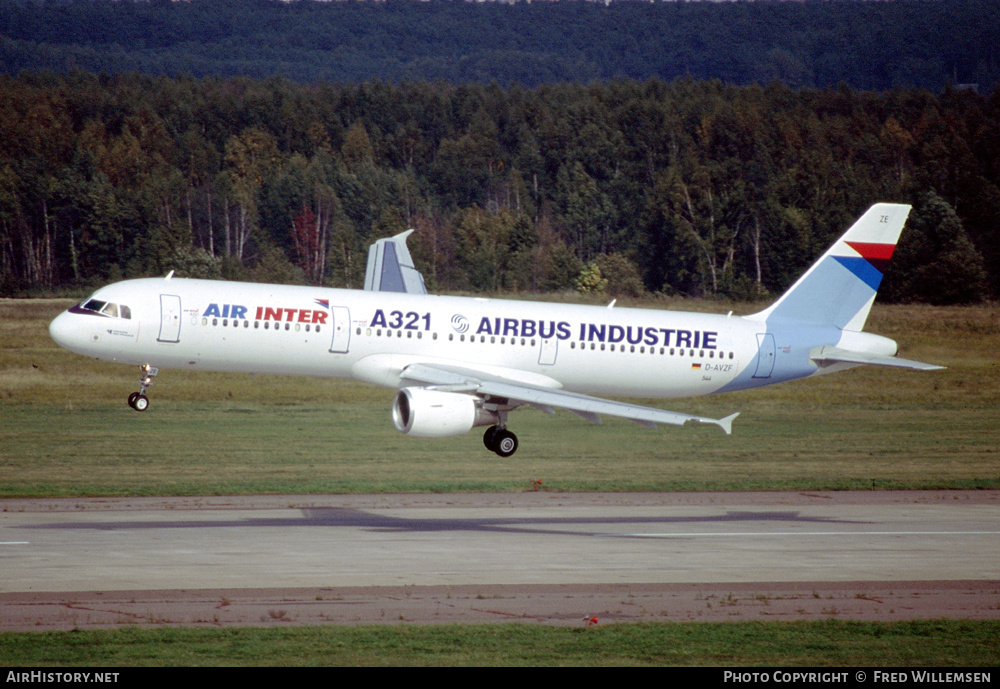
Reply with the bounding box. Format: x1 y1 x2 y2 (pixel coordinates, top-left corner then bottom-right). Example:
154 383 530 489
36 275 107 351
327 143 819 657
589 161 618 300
0 0 1000 92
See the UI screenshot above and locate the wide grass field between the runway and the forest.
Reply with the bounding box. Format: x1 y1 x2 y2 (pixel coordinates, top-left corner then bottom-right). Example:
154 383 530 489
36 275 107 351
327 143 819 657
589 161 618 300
0 300 1000 497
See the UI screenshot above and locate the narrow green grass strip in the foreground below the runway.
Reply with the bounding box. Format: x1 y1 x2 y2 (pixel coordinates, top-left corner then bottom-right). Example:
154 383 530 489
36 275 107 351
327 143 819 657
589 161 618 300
0 620 1000 668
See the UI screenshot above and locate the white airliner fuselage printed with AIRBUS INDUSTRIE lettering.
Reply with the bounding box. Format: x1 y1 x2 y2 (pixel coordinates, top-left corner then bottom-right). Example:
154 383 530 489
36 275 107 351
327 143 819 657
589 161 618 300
50 278 839 398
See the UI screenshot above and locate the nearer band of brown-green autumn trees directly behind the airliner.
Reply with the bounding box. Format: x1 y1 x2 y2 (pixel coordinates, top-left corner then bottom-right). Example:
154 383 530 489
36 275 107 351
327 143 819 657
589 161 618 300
0 72 1000 302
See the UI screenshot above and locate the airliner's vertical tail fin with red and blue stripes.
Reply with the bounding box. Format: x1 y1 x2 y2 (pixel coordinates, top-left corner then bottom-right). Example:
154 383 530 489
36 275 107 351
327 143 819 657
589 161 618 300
749 203 910 331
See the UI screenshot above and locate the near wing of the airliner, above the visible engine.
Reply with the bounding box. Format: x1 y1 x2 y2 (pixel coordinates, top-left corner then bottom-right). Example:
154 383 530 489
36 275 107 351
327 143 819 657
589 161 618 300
400 364 739 435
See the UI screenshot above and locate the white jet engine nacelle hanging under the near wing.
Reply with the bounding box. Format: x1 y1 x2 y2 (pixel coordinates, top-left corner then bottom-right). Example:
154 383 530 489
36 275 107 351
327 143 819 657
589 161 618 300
392 388 500 438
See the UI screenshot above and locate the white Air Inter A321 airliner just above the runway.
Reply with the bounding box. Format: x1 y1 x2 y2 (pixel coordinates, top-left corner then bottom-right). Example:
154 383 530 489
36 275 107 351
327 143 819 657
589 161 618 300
49 203 942 457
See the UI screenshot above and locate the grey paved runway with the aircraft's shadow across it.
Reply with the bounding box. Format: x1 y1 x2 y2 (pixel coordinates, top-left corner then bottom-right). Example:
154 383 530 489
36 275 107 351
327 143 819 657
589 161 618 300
0 491 1000 629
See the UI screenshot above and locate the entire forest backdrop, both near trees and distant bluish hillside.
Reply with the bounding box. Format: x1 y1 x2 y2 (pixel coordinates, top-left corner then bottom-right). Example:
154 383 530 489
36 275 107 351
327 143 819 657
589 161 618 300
0 0 1000 303
